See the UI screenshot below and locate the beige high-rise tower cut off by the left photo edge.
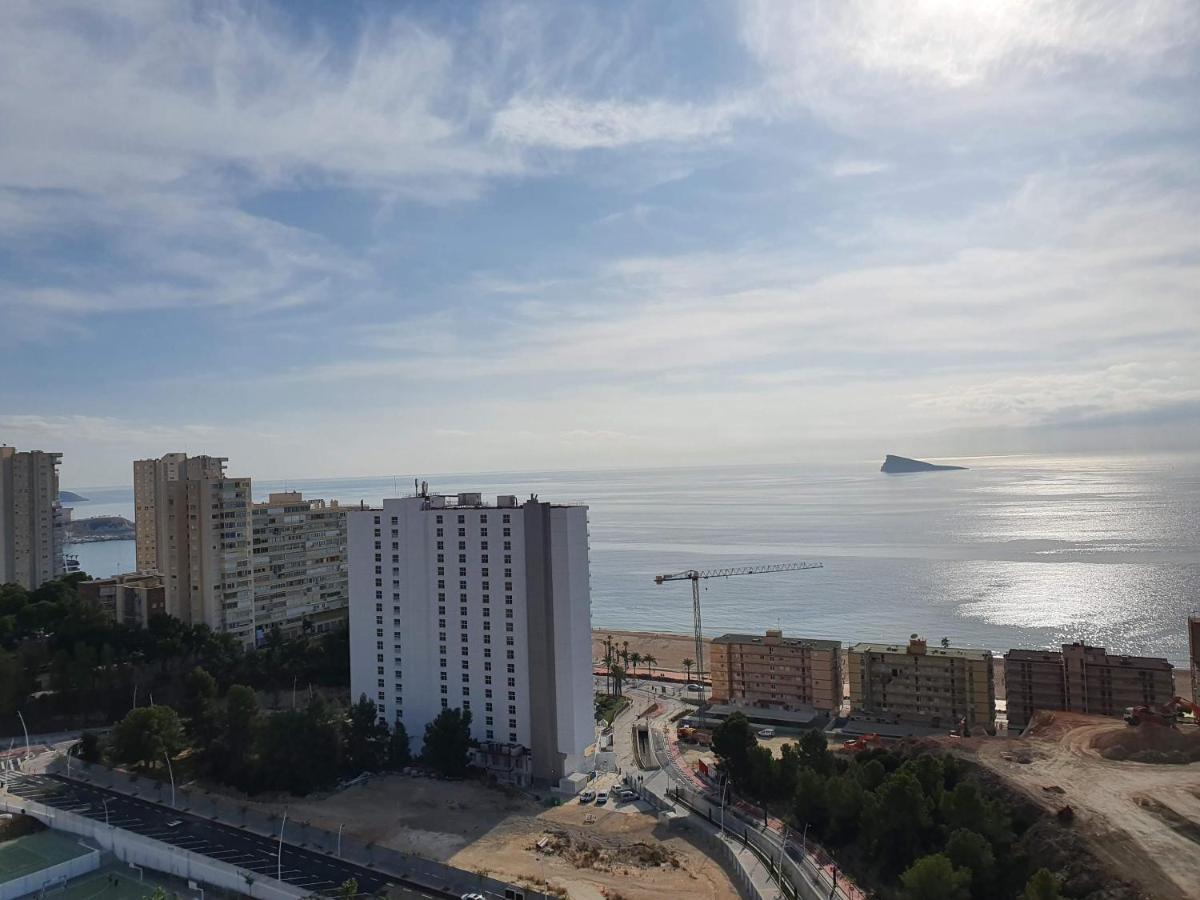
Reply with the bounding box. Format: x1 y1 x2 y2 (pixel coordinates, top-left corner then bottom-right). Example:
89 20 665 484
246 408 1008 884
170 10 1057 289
0 446 65 590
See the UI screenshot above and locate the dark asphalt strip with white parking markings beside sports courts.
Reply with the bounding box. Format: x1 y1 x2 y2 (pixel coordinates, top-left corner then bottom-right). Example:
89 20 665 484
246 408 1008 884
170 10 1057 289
1 774 441 898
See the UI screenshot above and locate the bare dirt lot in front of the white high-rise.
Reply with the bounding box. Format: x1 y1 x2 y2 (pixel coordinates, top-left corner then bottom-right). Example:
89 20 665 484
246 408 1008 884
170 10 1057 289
243 775 738 900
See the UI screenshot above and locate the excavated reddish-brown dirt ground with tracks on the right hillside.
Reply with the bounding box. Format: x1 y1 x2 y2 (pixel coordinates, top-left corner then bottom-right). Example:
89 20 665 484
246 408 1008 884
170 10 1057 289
958 713 1200 900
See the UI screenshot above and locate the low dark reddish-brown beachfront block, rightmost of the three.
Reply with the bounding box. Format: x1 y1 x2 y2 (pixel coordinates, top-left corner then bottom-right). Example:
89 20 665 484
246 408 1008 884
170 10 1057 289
1004 642 1175 727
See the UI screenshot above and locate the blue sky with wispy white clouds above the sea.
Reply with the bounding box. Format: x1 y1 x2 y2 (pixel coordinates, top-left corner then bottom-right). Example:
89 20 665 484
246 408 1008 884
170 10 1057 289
0 0 1200 486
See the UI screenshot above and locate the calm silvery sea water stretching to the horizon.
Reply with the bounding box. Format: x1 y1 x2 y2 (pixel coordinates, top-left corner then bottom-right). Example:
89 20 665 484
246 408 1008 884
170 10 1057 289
68 456 1200 662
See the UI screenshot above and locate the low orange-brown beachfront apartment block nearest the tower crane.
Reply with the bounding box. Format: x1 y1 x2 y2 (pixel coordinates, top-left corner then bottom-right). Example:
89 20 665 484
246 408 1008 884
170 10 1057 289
710 630 842 713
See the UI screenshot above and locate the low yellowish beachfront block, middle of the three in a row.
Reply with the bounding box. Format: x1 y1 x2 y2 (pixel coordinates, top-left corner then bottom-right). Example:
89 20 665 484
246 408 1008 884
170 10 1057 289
846 635 996 728
